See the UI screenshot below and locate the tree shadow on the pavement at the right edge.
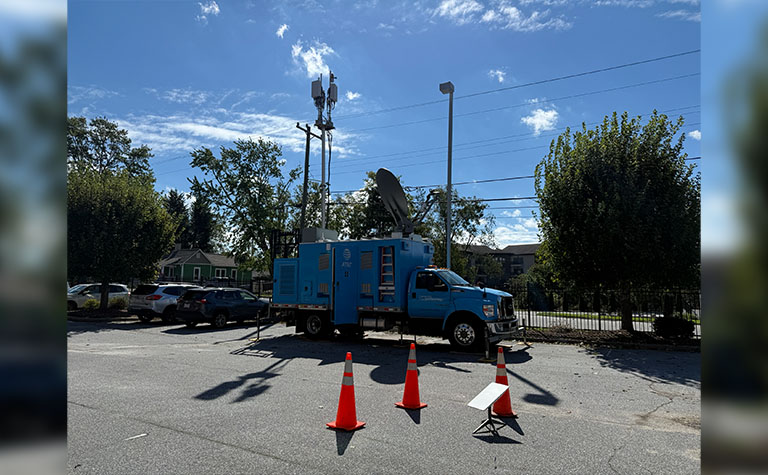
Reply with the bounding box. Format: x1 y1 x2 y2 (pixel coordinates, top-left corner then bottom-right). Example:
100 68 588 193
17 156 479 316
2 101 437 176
590 348 701 387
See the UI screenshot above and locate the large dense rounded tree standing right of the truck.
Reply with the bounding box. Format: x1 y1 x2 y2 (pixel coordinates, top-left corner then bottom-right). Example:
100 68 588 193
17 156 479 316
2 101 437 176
535 112 701 331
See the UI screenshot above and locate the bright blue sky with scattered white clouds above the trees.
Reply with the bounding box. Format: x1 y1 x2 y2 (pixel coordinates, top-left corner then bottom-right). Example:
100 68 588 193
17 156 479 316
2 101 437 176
68 0 702 246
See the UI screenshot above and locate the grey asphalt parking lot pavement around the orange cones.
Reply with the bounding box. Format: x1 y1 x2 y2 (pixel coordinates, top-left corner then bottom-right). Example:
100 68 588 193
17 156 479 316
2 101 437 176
67 322 701 474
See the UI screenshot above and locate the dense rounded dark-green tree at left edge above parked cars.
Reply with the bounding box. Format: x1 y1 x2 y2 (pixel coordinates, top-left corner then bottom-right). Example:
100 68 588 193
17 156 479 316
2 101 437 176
67 169 176 309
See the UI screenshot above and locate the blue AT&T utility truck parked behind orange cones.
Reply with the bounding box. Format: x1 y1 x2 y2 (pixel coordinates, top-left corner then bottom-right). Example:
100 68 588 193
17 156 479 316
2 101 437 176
272 233 518 349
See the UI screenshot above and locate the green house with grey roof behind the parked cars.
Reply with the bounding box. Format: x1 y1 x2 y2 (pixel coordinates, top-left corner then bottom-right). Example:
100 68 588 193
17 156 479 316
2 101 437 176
158 248 246 282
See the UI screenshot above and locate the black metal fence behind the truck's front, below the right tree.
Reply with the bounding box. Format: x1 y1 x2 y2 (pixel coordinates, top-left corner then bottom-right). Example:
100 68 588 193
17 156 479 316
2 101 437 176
506 285 701 338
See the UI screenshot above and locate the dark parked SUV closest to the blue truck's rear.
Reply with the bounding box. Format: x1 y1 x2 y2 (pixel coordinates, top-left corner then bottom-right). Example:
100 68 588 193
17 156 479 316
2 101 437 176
176 287 269 328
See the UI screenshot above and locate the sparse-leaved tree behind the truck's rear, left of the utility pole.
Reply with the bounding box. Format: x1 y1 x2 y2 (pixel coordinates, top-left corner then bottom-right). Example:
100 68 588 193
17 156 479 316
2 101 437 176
189 138 299 272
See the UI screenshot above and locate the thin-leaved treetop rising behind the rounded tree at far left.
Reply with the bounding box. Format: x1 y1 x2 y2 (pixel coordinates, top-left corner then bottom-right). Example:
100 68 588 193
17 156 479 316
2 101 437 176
67 117 152 176
